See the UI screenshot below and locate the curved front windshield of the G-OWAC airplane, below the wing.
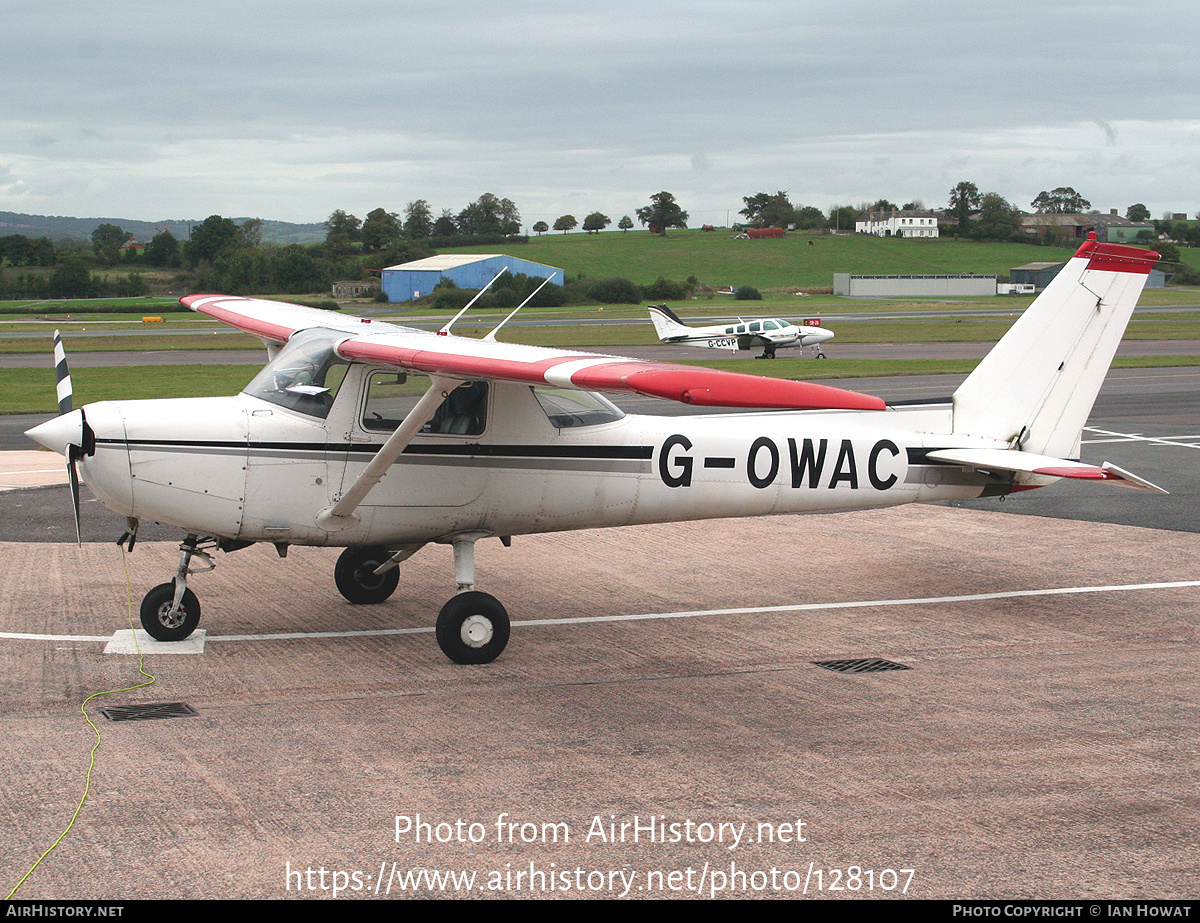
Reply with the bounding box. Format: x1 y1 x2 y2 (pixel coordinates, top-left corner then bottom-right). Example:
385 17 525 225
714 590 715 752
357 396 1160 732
242 330 350 419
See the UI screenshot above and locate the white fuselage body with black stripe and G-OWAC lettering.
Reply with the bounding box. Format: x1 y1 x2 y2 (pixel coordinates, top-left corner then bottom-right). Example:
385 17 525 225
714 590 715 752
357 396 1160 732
70 365 1010 547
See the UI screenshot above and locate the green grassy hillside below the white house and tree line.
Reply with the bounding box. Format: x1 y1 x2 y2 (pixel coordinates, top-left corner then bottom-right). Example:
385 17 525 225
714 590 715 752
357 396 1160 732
452 229 1075 289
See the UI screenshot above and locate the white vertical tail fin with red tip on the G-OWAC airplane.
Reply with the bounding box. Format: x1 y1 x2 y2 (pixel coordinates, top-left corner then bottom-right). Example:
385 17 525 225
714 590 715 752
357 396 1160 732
953 234 1158 457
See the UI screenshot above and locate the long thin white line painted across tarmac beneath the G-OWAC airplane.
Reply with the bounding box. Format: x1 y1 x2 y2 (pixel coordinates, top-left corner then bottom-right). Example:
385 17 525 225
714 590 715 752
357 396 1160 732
0 580 1200 643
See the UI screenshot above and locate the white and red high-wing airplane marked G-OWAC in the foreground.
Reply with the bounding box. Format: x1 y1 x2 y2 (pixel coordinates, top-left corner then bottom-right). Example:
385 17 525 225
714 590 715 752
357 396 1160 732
29 239 1160 663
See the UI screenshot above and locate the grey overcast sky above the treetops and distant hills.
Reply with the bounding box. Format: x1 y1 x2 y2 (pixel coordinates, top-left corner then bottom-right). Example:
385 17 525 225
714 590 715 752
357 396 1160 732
0 0 1200 228
